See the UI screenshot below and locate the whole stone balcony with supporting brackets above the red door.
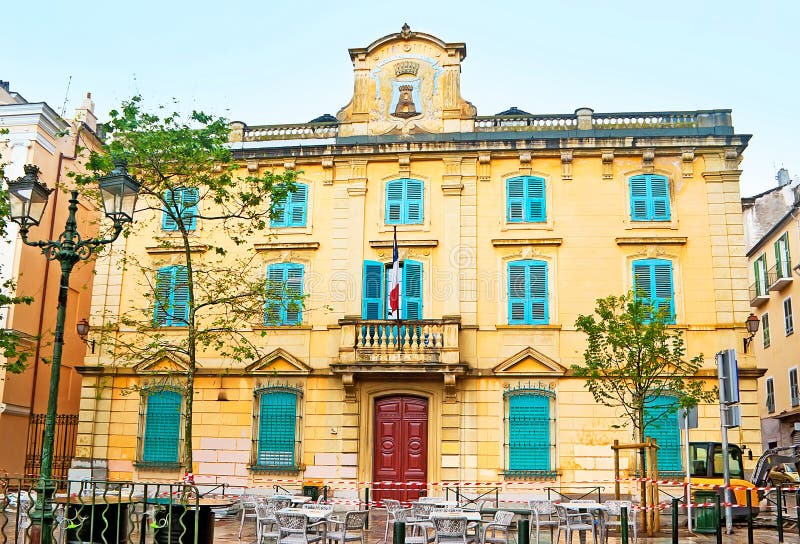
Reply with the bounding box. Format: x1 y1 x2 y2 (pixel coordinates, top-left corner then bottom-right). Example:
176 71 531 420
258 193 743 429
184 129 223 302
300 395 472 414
331 317 467 400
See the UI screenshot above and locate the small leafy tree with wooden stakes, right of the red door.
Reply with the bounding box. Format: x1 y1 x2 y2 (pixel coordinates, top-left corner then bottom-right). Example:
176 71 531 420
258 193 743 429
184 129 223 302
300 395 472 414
572 292 716 520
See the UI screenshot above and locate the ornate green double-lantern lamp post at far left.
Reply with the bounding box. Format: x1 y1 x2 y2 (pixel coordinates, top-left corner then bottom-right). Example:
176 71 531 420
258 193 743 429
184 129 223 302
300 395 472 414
7 160 139 544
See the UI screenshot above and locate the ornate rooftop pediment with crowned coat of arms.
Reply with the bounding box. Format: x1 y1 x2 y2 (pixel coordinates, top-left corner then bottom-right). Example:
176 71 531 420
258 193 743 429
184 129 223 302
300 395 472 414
337 25 477 136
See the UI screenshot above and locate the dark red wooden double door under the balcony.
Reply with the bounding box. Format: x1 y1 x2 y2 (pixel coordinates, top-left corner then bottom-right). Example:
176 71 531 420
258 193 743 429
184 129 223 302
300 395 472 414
372 396 428 502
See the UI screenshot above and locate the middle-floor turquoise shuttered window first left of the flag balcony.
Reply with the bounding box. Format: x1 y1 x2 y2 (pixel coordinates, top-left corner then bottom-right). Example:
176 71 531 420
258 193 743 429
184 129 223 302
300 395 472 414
264 263 303 326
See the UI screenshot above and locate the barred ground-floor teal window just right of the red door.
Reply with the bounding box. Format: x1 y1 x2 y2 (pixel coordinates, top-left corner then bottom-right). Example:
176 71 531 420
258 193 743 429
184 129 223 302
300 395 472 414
503 386 555 478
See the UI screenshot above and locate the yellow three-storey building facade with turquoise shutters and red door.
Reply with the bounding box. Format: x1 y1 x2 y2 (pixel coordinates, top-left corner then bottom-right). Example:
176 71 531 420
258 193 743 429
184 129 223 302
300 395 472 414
78 27 760 496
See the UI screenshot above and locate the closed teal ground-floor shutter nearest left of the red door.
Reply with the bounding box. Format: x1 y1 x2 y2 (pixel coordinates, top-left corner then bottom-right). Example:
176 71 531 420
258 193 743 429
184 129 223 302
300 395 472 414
257 391 297 467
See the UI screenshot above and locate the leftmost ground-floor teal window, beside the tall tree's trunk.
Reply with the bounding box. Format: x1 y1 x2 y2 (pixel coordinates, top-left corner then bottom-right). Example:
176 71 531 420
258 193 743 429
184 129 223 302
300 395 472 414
137 388 183 468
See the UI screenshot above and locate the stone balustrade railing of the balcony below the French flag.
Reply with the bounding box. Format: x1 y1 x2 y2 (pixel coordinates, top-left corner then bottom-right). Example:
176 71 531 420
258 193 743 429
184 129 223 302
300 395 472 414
339 318 459 364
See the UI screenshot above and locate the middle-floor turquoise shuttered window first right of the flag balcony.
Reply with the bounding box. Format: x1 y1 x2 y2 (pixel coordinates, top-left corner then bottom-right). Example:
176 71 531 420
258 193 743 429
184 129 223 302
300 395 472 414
508 260 549 325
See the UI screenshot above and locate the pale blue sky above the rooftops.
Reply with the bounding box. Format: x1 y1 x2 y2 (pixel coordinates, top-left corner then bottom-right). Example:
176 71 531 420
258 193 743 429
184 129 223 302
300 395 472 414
0 0 800 195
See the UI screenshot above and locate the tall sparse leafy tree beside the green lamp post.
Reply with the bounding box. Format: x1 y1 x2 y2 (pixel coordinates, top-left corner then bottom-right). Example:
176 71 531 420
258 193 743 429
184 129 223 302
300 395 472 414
76 96 302 471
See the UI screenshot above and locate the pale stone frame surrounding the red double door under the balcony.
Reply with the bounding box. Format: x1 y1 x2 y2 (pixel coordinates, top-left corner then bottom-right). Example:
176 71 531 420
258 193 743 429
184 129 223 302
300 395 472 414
358 380 444 492
